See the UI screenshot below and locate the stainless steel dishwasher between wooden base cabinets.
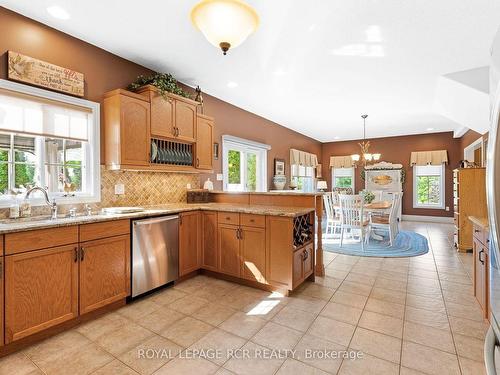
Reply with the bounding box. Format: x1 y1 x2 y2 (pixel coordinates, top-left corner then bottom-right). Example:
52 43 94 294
132 215 179 297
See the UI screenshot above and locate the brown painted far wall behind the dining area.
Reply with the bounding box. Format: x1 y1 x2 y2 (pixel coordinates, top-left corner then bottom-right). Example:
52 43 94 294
322 132 462 216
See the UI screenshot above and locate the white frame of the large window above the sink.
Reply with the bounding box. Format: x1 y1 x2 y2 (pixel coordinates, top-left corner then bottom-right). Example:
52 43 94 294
0 79 101 208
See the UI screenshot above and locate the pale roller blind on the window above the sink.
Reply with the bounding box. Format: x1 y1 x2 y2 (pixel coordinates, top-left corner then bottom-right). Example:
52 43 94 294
0 89 91 141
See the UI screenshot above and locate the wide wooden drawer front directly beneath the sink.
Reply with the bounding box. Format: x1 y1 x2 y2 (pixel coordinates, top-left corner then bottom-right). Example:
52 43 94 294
5 225 78 255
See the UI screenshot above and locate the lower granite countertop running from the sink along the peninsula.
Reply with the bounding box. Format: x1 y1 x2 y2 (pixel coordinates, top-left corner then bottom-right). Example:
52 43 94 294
0 203 314 234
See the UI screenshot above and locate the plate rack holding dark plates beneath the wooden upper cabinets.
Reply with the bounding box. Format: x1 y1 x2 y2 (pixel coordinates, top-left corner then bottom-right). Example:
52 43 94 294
150 138 194 166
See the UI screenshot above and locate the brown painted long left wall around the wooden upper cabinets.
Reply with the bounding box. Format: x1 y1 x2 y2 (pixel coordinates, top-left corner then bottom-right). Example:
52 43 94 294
0 7 321 189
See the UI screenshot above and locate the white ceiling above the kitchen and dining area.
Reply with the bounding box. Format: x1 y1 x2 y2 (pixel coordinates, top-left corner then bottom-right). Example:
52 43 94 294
0 0 500 141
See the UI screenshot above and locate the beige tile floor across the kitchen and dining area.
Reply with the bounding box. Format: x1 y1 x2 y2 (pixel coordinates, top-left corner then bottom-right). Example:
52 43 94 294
0 223 487 375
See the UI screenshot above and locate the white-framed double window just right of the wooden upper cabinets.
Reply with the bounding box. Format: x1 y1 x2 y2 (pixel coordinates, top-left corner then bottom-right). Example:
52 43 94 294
222 135 271 191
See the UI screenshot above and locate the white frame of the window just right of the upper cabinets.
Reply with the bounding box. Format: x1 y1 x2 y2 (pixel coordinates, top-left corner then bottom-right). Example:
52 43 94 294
222 135 271 192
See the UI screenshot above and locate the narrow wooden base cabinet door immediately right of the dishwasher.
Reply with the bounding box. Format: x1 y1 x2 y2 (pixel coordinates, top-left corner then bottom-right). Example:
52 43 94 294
179 211 201 276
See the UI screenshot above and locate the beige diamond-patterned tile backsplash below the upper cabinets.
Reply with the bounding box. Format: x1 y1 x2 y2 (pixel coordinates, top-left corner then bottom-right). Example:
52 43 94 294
0 166 200 218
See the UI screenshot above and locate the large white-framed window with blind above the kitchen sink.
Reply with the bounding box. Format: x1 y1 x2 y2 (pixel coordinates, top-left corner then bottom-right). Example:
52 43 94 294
0 80 100 207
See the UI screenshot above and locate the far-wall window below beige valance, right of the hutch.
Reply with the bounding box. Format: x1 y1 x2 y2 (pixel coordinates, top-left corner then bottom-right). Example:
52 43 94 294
413 164 445 209
